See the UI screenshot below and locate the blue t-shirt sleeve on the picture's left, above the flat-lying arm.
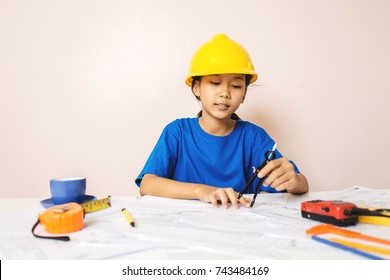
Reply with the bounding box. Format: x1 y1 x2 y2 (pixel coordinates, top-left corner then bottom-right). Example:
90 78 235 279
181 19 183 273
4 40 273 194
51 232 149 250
135 124 179 187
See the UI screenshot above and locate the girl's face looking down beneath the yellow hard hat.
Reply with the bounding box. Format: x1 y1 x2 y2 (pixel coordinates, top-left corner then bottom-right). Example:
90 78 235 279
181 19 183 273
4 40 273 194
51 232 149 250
193 74 246 119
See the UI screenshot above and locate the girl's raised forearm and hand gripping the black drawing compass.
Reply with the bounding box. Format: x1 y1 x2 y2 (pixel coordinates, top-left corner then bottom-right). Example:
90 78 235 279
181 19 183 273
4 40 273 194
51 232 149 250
258 158 309 194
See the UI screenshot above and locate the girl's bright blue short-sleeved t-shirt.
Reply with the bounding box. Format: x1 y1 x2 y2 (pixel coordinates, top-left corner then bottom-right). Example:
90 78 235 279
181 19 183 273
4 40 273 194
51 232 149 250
135 118 299 193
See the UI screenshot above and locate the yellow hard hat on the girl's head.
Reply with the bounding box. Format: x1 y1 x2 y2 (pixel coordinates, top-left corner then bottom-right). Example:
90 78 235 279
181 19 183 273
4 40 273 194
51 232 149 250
185 34 257 86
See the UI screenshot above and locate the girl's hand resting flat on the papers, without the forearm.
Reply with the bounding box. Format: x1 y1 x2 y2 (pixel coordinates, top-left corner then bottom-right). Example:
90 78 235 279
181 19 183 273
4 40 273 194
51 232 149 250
196 185 250 208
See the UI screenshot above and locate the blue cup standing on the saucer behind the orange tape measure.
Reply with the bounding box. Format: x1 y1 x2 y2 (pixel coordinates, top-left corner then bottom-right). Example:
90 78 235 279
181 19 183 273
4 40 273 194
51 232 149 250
50 177 87 205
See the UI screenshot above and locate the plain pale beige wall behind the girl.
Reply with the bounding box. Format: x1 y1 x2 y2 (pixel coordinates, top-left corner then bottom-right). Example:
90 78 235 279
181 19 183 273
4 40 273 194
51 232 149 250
0 0 390 198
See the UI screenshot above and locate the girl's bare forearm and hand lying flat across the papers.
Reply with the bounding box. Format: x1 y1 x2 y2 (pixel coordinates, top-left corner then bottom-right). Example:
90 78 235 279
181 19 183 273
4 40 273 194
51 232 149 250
140 174 250 208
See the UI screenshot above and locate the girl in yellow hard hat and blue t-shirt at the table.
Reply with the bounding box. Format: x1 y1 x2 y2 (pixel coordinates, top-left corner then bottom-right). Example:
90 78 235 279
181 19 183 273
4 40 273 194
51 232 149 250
135 34 309 208
